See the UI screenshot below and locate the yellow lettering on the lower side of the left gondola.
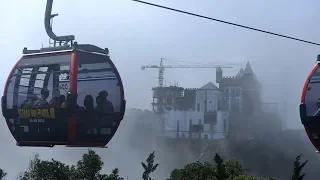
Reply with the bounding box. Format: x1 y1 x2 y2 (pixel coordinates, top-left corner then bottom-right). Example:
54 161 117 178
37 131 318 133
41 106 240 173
18 108 56 119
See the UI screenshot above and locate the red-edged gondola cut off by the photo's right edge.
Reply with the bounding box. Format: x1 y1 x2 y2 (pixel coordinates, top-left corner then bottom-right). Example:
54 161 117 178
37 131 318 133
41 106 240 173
300 55 320 151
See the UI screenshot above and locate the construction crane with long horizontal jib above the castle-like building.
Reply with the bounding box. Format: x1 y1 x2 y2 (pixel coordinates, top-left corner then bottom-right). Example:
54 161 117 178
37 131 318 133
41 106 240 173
141 58 233 87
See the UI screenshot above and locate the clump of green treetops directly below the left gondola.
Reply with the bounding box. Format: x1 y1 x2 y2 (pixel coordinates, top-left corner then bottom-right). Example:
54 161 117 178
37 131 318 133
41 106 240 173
17 149 123 180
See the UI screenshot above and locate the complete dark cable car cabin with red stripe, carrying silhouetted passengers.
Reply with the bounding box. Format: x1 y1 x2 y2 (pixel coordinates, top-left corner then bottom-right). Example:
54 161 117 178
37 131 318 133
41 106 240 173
2 49 125 147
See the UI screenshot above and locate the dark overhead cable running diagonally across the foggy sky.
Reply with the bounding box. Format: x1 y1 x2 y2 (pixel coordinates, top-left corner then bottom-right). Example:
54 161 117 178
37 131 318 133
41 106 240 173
132 0 320 46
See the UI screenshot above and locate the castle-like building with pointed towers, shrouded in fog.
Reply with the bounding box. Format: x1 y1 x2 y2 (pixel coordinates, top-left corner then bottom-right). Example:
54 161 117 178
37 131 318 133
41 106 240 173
152 62 261 139
